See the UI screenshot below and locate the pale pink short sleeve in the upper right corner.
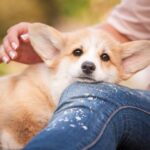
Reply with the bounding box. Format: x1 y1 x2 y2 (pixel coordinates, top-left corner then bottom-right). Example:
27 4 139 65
107 0 150 40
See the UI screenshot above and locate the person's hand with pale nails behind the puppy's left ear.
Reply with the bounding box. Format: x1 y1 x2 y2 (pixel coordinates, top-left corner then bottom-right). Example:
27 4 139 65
0 22 42 64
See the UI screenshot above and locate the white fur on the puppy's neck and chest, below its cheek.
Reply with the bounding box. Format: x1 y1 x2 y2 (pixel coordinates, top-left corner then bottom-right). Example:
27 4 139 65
39 65 73 105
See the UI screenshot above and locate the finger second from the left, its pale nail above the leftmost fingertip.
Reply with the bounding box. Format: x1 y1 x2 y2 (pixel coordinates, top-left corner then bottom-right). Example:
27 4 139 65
3 37 17 59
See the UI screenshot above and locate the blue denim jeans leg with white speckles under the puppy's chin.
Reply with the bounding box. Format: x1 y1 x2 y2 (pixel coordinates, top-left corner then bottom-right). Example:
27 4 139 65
25 83 150 150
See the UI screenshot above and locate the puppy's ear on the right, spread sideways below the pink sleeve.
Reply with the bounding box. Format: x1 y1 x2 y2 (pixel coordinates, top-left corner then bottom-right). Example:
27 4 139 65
121 40 150 79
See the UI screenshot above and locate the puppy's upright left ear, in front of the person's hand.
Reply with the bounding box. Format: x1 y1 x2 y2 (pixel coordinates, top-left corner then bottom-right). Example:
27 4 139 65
29 23 64 65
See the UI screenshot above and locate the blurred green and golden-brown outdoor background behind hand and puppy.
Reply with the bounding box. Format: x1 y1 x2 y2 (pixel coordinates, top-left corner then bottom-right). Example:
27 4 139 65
0 0 119 75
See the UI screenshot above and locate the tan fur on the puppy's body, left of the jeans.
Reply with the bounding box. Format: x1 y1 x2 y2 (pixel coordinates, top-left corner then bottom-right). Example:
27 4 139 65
0 65 55 149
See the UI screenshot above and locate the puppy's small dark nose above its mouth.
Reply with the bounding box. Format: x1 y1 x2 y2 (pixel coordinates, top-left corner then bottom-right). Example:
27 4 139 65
81 61 96 74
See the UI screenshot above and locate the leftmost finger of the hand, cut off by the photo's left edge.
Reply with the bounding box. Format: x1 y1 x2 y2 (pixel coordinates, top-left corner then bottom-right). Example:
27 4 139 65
0 46 10 64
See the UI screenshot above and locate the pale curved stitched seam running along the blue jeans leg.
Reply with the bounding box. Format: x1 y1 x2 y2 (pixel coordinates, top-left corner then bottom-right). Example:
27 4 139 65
82 105 150 150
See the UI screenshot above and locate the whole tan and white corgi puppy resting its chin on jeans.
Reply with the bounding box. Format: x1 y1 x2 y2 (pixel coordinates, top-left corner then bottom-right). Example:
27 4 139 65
0 23 150 150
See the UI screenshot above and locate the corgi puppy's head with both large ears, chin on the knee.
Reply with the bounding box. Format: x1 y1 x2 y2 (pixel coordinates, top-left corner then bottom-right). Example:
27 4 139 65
29 23 150 83
